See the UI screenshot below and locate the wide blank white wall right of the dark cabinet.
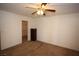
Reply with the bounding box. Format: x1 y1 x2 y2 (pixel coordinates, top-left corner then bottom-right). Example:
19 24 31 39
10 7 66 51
34 13 79 51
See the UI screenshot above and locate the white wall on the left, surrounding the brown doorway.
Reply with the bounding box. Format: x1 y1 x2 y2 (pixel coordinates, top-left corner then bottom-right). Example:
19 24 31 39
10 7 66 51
0 11 30 50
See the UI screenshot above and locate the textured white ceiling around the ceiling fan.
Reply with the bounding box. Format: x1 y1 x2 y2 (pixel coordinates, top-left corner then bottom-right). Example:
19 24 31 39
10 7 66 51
0 3 79 16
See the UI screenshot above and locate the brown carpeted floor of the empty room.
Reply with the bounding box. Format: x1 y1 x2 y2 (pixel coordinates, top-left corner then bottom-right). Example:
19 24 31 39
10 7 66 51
0 41 79 56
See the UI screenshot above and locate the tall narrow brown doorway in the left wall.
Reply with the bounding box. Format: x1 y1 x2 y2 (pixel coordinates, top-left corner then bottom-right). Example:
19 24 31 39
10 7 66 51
22 21 28 43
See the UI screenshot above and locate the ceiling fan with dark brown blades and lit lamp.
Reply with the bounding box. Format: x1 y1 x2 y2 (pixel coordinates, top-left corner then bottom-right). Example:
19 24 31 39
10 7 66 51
26 3 56 16
